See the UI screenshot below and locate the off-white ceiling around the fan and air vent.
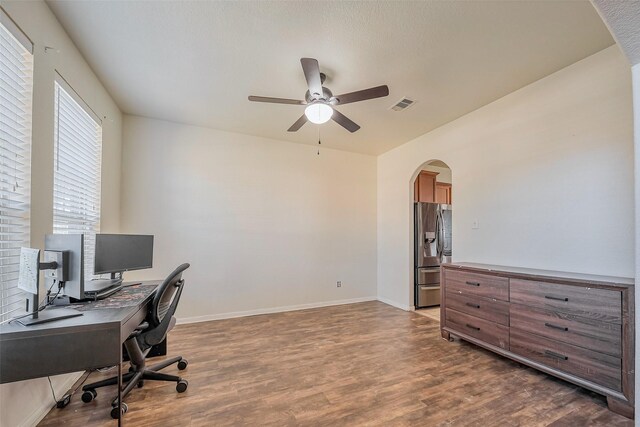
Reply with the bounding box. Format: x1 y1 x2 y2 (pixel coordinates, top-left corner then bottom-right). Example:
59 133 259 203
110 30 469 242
48 0 614 154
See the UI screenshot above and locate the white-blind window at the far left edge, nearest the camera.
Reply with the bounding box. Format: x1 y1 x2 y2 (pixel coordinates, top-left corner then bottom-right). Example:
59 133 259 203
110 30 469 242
0 9 33 321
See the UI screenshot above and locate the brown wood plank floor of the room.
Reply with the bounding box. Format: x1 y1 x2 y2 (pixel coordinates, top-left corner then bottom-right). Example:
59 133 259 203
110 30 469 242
40 302 633 427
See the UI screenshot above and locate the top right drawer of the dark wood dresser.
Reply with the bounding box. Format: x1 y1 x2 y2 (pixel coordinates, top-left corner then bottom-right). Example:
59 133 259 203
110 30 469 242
510 279 622 324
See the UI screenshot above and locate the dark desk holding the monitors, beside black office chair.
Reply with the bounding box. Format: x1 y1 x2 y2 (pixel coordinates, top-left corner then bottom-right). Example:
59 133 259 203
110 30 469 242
0 280 162 425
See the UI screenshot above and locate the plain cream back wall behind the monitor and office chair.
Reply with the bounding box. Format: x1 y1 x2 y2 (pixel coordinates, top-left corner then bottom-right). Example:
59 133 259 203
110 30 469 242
121 115 376 321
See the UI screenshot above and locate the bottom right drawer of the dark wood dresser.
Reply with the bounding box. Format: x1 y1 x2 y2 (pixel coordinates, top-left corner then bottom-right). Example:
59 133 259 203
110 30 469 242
509 328 622 391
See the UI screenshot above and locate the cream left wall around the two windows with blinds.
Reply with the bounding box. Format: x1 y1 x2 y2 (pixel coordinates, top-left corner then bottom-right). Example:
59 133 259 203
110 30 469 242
0 1 122 426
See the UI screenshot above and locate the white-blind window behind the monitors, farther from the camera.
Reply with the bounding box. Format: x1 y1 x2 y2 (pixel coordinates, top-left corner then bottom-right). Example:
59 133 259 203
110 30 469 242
53 76 102 279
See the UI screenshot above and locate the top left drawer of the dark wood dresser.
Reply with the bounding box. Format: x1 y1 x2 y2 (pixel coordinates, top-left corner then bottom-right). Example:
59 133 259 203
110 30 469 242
445 270 509 301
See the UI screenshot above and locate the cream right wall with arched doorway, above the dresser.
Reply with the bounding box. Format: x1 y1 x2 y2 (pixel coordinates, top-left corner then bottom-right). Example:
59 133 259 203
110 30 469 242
378 46 634 308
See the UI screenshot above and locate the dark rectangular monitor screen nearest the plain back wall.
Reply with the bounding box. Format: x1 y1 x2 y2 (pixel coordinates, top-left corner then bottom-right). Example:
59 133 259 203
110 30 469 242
94 234 153 274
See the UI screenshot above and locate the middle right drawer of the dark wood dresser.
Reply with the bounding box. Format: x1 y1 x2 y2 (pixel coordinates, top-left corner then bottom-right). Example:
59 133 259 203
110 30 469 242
509 304 622 357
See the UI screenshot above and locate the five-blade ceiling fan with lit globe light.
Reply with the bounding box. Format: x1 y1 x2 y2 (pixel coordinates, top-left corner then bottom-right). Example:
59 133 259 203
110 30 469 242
249 58 389 132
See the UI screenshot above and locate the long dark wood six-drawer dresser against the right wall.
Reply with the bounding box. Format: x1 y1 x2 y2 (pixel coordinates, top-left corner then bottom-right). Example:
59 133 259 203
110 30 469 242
440 263 635 418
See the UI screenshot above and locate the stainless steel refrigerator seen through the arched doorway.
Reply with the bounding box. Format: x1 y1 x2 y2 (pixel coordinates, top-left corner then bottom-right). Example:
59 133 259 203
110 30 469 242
414 202 451 308
